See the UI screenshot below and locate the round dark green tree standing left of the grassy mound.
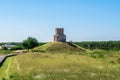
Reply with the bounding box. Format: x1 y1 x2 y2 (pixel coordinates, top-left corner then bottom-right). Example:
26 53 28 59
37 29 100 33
22 37 39 51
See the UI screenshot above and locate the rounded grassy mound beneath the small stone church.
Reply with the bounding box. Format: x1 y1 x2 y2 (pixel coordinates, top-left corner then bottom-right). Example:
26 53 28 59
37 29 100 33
33 42 86 53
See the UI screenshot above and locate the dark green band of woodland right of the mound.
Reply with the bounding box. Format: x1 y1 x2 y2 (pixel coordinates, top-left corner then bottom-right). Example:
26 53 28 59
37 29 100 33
74 41 120 50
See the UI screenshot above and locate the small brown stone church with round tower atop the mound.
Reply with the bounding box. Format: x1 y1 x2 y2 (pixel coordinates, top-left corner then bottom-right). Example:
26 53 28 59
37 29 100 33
54 28 66 42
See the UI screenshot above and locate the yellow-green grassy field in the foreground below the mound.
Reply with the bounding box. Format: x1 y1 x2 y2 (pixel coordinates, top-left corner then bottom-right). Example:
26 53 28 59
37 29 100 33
0 50 120 80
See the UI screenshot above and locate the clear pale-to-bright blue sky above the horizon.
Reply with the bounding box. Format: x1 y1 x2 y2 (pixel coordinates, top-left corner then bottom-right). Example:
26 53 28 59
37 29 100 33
0 0 120 42
